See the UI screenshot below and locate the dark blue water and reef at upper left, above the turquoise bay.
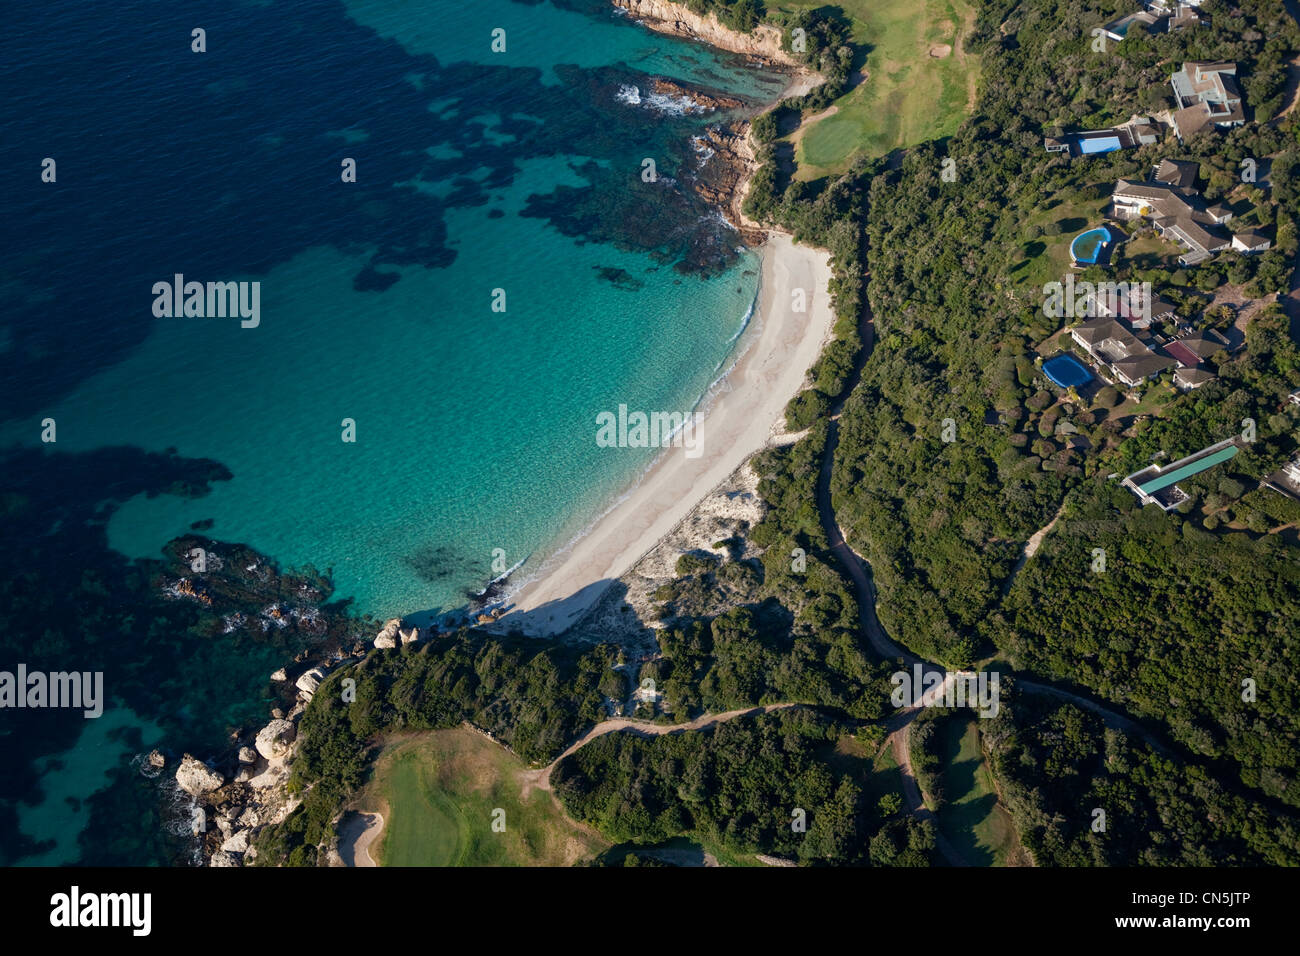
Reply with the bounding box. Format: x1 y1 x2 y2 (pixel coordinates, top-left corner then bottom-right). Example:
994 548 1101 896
0 0 764 418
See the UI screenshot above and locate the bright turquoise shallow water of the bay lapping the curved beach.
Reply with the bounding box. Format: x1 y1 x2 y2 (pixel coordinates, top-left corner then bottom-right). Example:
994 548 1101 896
91 227 755 614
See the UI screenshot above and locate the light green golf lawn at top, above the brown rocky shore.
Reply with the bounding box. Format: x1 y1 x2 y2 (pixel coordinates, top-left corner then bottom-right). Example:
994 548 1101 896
780 0 979 179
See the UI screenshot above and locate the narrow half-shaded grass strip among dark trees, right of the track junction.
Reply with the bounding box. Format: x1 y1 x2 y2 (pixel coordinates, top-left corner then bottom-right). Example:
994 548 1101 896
939 717 1023 866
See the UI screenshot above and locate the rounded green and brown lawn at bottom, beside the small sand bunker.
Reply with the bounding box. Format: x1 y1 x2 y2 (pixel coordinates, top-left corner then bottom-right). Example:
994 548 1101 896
358 728 608 866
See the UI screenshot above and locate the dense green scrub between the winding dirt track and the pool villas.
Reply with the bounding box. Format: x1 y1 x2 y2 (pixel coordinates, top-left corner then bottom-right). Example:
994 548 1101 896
835 3 1296 665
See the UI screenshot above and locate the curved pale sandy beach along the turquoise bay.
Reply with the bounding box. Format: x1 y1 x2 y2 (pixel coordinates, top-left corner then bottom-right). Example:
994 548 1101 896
493 234 835 636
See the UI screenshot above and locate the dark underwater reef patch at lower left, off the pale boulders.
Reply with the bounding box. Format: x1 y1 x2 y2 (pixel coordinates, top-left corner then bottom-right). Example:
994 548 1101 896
0 449 364 865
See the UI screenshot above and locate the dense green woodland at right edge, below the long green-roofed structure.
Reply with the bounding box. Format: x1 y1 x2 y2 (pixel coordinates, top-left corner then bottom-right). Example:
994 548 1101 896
997 486 1300 805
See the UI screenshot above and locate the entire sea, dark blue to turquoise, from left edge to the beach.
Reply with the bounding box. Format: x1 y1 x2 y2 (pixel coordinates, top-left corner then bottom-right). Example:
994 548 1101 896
0 0 783 864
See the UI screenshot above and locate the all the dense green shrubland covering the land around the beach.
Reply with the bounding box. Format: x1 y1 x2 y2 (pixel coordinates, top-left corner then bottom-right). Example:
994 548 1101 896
269 0 1300 865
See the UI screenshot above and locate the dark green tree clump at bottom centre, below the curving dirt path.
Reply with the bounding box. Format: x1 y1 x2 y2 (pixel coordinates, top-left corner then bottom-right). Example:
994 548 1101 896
551 709 933 866
